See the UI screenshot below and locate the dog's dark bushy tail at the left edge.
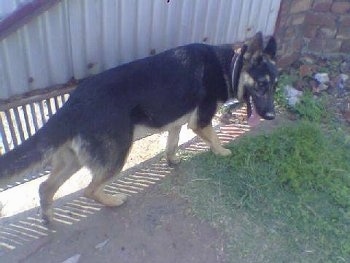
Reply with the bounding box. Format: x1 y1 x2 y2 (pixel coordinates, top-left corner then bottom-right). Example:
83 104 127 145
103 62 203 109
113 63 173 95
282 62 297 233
0 115 69 185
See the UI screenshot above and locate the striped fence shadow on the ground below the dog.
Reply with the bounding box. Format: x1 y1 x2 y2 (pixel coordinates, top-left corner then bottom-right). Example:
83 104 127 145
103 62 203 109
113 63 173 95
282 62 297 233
0 115 249 256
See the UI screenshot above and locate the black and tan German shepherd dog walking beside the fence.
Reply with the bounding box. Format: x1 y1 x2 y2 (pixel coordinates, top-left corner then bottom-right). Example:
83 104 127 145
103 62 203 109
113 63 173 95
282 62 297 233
0 32 277 223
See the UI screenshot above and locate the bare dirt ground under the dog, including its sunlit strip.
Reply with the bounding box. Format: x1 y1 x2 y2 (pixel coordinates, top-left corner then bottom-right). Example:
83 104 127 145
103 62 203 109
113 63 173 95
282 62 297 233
0 108 253 263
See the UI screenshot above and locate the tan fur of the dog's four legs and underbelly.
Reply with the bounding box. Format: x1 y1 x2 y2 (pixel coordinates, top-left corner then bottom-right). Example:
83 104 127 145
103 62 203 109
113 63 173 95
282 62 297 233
40 106 231 222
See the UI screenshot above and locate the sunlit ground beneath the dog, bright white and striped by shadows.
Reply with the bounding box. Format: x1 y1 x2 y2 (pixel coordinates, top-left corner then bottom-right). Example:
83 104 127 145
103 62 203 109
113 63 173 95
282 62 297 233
0 109 249 251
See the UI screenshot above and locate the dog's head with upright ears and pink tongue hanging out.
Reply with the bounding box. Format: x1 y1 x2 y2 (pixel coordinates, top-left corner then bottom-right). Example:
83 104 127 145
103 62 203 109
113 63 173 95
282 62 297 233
237 32 278 125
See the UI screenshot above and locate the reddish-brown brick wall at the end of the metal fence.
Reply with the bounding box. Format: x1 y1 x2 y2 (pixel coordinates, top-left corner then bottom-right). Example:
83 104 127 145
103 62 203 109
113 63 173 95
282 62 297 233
275 0 350 67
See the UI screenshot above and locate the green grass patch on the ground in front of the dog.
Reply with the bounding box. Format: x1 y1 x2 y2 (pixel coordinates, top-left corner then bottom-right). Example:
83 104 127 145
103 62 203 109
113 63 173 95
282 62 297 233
169 121 350 262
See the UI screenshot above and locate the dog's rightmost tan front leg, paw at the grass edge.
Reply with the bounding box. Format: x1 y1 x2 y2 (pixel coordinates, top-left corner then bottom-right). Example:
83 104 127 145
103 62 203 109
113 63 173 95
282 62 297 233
189 124 231 156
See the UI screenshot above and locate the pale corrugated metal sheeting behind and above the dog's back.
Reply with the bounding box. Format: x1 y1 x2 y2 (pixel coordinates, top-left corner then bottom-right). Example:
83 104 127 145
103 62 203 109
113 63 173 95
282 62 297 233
0 0 281 98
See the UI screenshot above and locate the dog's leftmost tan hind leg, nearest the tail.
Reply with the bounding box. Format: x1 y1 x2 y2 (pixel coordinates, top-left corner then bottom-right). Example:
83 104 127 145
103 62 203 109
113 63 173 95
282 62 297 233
39 145 81 223
